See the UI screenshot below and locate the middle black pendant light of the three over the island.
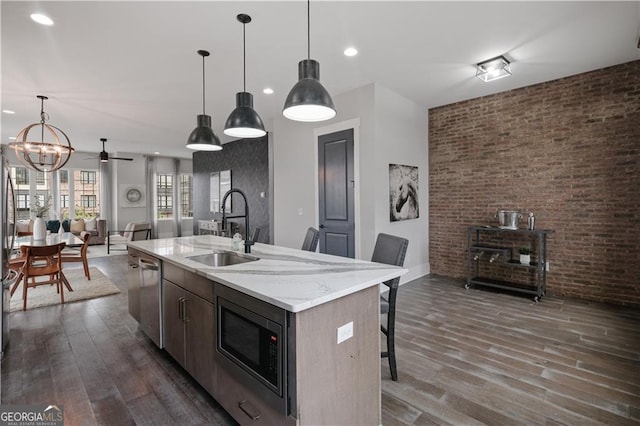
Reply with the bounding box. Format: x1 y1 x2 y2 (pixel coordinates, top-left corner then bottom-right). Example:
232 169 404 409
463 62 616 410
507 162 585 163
224 13 267 138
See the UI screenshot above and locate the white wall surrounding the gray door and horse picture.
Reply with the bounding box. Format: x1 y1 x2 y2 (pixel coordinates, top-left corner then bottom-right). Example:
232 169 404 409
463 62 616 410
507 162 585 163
273 84 429 282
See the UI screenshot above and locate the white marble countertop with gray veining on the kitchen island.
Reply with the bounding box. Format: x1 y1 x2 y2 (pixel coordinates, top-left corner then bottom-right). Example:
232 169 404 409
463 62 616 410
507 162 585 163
128 235 408 312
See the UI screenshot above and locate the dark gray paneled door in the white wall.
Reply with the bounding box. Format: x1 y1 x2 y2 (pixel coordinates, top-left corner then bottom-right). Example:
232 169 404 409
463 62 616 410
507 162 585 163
318 129 356 258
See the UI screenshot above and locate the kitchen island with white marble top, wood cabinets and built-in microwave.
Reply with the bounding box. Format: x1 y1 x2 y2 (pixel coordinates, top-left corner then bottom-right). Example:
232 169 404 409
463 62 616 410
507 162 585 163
129 235 407 424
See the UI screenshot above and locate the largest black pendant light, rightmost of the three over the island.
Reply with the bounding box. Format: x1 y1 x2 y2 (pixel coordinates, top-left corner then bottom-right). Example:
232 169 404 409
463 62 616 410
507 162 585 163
282 0 336 121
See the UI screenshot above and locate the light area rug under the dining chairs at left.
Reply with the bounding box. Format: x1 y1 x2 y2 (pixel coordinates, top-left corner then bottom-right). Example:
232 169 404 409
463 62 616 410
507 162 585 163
11 267 120 312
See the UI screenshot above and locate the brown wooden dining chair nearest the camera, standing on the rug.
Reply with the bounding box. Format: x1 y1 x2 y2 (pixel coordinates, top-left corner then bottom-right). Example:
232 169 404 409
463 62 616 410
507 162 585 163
22 243 71 311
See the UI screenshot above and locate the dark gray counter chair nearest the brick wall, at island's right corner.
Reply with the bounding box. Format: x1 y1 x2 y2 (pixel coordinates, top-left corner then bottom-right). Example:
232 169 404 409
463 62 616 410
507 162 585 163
371 233 409 382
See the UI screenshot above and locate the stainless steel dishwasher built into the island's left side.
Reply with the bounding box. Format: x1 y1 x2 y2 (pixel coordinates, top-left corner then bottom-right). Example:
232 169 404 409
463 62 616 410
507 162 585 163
138 253 164 348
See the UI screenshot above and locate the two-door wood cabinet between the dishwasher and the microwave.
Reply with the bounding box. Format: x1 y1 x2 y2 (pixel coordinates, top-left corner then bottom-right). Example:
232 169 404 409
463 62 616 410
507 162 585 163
162 262 216 395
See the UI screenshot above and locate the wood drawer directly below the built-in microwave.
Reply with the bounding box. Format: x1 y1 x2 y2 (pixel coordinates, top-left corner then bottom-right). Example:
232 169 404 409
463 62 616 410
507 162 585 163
216 368 296 425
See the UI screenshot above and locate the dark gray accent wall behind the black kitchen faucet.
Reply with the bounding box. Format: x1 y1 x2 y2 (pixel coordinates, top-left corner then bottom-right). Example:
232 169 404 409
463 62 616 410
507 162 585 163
193 136 271 243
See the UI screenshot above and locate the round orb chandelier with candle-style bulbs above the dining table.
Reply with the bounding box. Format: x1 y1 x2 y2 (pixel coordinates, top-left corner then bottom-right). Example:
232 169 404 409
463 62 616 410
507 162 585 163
9 95 73 172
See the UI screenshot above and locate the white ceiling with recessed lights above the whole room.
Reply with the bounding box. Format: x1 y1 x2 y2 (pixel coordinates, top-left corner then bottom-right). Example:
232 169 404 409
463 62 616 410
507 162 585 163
0 0 640 158
